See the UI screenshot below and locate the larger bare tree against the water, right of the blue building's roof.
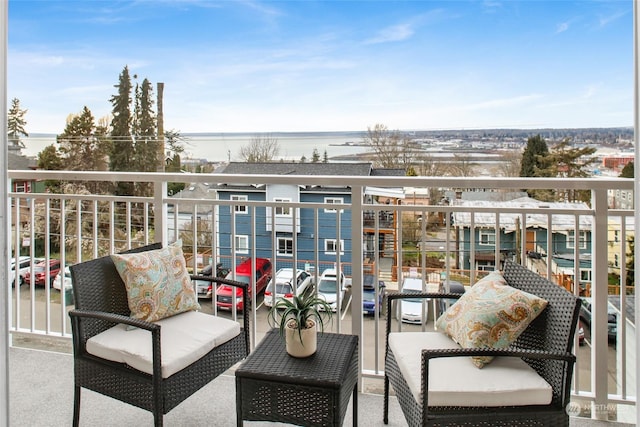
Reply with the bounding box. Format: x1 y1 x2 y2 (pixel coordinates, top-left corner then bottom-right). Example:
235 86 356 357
362 123 420 169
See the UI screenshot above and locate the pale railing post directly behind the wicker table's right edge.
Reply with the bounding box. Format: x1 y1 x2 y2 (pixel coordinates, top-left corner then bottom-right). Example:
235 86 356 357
352 185 364 390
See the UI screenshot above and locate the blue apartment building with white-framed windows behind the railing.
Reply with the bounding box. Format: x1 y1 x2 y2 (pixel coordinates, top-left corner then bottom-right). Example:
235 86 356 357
216 162 404 274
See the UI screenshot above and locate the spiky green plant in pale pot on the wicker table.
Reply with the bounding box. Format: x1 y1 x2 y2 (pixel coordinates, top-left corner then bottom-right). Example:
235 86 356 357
268 292 332 358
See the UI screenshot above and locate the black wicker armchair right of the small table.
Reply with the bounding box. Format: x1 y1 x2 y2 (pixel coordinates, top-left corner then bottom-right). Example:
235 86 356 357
383 261 580 427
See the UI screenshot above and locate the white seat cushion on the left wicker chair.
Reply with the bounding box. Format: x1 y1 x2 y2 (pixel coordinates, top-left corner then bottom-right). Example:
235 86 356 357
87 311 240 378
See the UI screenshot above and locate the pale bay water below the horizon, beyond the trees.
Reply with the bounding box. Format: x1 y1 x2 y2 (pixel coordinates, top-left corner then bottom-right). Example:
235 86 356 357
22 132 366 162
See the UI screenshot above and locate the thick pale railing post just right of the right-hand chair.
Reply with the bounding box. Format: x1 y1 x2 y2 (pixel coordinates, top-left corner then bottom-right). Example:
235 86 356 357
592 190 609 420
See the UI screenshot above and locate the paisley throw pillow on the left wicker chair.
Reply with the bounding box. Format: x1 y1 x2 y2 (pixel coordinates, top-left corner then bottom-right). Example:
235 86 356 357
111 241 200 322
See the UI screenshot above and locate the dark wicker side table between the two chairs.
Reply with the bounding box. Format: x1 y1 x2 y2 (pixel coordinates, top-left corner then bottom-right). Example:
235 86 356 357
236 329 358 426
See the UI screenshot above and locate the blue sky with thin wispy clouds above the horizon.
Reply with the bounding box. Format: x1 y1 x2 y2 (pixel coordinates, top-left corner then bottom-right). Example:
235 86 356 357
7 0 633 133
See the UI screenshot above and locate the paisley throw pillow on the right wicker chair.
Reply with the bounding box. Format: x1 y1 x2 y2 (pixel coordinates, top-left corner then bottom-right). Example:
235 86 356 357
436 271 547 368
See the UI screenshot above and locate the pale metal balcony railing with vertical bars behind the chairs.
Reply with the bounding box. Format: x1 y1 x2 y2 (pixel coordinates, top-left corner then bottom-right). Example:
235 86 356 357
8 171 637 418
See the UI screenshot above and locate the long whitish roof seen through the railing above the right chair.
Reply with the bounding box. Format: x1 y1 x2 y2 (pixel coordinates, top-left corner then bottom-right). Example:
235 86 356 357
453 197 593 232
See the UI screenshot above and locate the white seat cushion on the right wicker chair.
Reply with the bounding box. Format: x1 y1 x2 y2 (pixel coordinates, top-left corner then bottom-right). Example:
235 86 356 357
389 332 552 407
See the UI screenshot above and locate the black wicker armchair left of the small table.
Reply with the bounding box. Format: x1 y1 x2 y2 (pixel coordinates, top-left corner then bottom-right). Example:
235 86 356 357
69 244 250 426
